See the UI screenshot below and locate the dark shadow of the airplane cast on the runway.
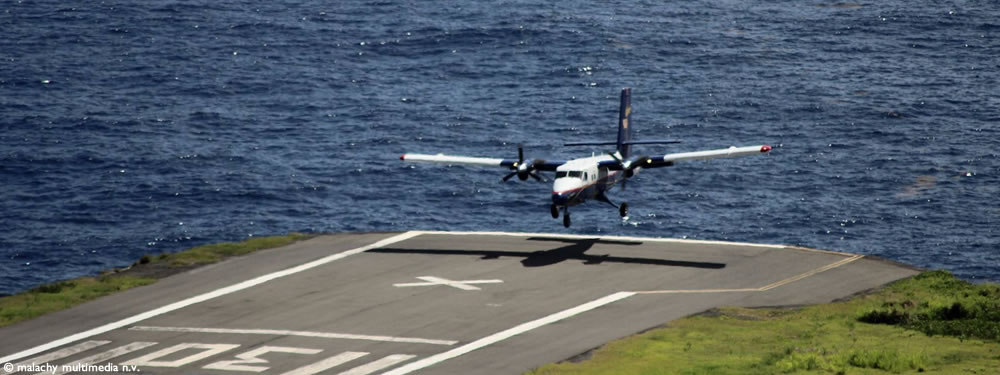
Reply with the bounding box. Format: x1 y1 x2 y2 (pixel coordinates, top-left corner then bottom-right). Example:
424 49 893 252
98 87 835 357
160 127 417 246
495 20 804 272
367 237 726 269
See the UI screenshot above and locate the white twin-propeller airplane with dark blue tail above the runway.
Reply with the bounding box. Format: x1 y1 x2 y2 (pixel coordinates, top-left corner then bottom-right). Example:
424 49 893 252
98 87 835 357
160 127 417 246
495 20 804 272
399 87 771 228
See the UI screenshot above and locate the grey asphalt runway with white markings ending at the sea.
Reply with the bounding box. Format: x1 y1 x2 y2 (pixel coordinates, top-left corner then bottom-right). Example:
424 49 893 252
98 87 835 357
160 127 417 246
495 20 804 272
0 232 919 375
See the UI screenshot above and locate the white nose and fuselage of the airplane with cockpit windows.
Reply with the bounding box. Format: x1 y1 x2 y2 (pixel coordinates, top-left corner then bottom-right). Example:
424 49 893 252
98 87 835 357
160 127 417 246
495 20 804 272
552 155 624 208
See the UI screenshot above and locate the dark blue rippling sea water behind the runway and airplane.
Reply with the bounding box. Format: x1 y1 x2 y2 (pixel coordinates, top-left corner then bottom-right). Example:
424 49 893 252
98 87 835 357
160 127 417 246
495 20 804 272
0 0 1000 294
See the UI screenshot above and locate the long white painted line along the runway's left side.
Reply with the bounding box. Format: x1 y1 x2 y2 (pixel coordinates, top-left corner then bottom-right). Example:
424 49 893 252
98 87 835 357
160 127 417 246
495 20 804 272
0 232 422 363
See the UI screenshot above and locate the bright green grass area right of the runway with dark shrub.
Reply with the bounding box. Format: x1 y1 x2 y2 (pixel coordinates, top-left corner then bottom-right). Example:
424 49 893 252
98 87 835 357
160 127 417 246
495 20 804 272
529 271 1000 375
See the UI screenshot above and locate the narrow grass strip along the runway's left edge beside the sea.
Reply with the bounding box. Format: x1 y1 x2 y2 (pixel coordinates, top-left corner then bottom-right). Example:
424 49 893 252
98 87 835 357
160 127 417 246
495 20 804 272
0 233 311 327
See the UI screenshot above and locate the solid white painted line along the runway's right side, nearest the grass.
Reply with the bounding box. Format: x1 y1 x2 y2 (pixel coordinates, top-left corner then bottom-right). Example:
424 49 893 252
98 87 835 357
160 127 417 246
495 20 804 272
382 292 635 375
